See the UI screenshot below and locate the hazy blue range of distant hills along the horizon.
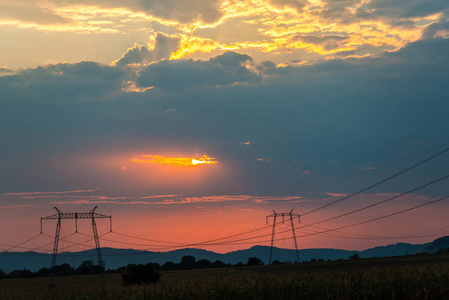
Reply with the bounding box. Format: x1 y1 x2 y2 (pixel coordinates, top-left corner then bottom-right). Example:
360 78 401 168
0 237 449 272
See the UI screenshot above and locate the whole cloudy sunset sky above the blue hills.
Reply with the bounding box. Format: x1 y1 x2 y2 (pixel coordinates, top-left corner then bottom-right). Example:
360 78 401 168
0 0 449 258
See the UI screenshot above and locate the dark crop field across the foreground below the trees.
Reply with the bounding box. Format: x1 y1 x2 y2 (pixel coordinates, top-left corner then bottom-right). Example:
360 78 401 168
0 254 449 299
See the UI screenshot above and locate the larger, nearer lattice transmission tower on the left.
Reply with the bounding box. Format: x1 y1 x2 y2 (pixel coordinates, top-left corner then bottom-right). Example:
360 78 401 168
41 206 112 287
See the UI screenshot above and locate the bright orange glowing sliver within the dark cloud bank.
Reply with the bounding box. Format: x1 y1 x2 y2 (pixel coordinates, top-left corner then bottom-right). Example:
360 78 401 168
131 155 218 166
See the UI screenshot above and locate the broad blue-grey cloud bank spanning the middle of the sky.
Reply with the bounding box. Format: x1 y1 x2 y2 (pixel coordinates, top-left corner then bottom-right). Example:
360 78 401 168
0 39 449 196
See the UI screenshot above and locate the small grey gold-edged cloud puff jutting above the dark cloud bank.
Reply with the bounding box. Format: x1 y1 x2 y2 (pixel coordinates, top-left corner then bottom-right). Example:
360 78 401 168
111 32 180 67
